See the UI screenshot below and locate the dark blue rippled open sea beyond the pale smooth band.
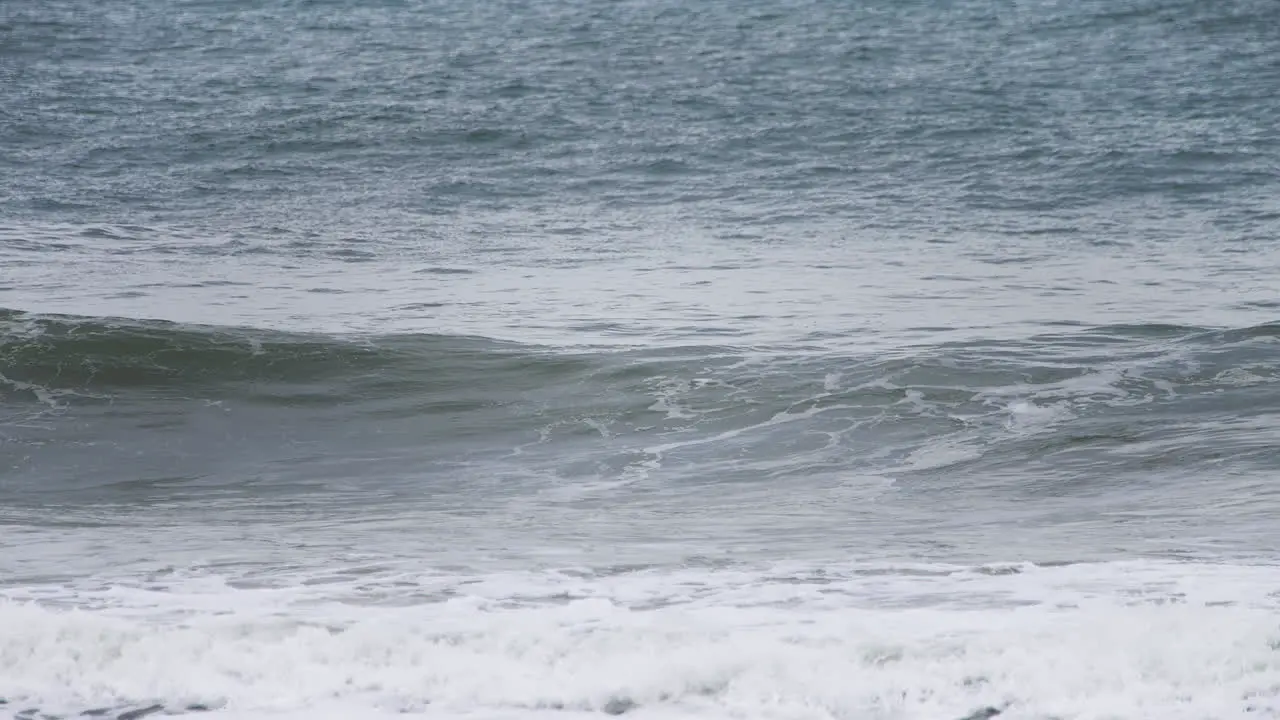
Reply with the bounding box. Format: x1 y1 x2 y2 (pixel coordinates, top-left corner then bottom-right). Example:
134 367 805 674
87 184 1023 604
0 0 1280 237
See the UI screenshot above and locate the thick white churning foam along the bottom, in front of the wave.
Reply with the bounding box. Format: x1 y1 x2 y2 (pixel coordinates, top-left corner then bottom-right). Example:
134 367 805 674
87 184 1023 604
0 562 1280 719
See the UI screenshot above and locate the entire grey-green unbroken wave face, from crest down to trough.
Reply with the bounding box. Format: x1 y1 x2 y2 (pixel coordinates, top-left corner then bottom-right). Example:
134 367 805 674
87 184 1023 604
0 304 1280 560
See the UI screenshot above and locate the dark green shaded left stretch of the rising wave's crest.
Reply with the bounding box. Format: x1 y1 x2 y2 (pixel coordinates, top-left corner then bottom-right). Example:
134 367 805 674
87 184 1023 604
0 304 582 404
